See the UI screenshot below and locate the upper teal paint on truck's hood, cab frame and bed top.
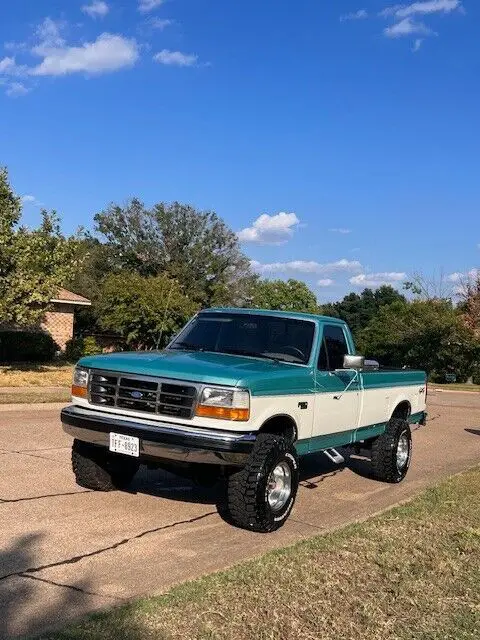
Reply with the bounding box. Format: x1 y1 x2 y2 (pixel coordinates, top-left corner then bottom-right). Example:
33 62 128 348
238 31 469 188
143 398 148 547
79 309 426 397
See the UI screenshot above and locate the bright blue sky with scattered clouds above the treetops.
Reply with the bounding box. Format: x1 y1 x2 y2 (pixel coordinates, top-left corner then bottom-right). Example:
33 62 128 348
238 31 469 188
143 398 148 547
0 0 480 301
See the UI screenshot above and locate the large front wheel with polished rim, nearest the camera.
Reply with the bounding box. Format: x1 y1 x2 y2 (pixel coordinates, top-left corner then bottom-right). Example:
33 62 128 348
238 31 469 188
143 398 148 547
228 433 299 533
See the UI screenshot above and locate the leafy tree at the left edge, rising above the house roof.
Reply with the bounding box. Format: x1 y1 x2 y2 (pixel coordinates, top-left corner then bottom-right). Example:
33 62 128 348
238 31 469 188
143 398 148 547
0 169 78 326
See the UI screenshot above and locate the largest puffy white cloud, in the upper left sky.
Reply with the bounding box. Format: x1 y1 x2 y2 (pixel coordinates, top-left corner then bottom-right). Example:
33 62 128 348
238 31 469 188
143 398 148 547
29 33 139 76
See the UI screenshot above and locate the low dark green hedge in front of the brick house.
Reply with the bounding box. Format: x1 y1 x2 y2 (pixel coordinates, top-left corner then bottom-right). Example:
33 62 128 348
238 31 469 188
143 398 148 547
0 331 59 363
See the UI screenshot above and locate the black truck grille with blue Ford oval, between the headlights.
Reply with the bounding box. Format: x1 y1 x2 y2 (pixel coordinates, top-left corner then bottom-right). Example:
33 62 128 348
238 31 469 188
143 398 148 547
88 371 197 418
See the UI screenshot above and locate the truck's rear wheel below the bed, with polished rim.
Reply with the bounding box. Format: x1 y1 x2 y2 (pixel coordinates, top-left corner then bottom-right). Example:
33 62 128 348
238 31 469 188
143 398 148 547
372 418 412 483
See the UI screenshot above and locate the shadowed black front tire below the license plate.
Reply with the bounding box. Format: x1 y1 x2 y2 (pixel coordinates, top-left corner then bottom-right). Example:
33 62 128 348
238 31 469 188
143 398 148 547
72 440 140 491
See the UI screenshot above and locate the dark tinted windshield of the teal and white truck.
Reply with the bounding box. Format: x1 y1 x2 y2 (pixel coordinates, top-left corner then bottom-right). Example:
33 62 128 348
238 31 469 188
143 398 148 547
169 313 315 364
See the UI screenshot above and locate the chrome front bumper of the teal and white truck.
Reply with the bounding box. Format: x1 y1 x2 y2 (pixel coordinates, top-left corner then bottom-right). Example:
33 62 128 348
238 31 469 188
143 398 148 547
61 405 256 466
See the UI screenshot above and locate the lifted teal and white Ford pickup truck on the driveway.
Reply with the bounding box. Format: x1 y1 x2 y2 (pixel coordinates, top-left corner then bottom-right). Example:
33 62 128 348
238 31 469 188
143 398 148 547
62 309 427 532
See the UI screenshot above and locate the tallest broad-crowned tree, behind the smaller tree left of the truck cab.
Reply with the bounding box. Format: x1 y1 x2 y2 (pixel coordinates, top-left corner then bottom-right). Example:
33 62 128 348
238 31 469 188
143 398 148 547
95 199 254 306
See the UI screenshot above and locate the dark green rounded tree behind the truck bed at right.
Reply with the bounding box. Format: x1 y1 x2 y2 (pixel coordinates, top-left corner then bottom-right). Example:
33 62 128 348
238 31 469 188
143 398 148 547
358 300 480 380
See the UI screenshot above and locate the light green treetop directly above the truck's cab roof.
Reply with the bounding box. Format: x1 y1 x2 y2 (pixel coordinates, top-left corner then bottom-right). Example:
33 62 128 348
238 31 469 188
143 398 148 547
249 279 319 313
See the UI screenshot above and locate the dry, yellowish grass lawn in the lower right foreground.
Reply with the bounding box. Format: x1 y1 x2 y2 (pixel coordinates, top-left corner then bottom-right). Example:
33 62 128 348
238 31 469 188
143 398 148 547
34 468 480 640
